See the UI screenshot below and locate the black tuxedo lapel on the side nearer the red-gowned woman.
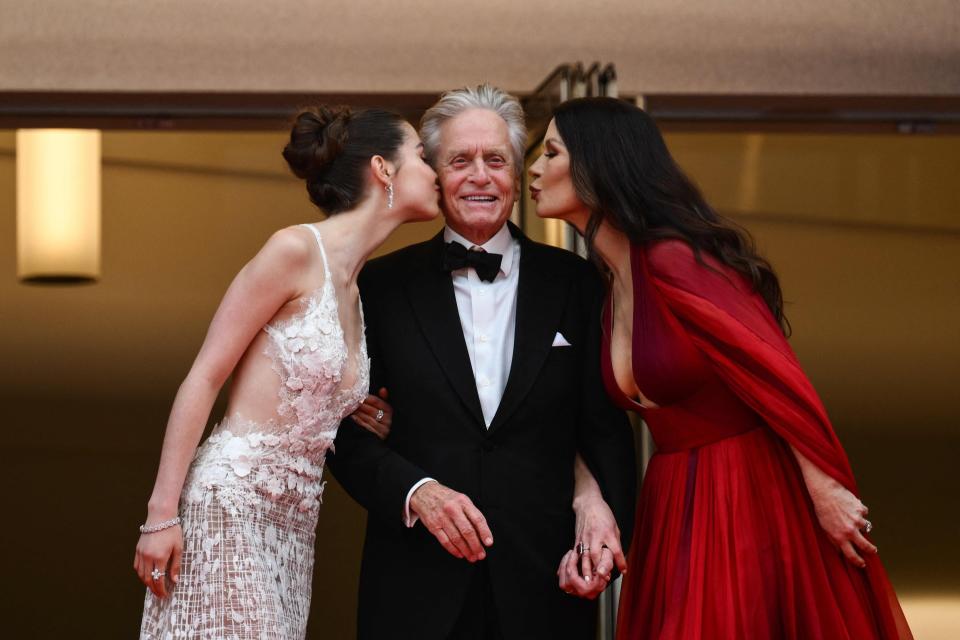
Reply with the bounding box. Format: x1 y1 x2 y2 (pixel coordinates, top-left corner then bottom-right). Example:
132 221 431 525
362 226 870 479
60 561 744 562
490 227 569 432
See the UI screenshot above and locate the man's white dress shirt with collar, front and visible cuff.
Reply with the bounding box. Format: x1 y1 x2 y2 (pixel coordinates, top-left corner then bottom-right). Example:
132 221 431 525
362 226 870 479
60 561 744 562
403 224 520 527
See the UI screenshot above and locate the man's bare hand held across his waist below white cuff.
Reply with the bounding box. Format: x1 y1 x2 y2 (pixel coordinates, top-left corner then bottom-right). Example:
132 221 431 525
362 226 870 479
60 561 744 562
410 482 493 562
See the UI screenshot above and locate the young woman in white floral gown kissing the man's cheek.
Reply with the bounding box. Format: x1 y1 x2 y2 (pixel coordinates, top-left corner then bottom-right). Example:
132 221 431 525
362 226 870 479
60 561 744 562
134 107 439 640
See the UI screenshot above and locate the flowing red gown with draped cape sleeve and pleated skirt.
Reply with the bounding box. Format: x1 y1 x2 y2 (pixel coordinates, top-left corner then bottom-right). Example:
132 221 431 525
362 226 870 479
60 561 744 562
603 241 912 640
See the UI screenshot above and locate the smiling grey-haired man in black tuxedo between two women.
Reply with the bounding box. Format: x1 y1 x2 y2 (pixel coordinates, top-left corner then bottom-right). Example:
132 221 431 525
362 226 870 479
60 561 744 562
329 85 636 640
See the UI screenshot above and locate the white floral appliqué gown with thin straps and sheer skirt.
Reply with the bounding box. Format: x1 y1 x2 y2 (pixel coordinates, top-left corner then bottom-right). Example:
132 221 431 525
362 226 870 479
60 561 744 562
140 225 370 640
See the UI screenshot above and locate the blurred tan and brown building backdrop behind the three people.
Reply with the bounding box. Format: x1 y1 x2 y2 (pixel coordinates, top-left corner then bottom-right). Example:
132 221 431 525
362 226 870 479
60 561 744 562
0 0 960 639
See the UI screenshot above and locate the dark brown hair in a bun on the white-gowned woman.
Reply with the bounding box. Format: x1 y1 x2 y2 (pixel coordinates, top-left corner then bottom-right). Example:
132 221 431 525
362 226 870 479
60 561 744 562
283 105 403 215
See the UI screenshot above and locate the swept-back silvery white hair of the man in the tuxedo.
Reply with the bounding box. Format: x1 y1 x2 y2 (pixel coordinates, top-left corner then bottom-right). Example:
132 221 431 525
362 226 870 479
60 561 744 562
420 84 527 178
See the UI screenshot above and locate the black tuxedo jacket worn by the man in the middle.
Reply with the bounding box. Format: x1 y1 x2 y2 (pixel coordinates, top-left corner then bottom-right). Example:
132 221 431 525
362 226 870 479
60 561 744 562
328 226 636 640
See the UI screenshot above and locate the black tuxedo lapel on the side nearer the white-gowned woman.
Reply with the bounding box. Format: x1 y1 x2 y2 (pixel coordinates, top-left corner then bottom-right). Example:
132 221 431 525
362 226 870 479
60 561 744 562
406 231 488 428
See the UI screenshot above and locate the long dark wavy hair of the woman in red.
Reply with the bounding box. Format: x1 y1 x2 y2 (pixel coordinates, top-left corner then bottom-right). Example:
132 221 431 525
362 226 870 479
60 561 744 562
553 98 790 335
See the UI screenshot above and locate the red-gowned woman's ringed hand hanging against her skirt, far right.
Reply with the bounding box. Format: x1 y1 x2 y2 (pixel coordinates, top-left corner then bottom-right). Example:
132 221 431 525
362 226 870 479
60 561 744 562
808 477 877 569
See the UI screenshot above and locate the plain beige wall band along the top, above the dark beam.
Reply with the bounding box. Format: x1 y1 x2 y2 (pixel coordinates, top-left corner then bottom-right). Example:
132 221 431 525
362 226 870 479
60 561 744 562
0 0 960 95
